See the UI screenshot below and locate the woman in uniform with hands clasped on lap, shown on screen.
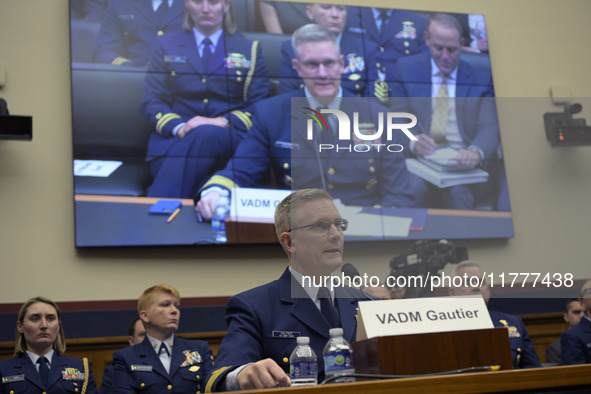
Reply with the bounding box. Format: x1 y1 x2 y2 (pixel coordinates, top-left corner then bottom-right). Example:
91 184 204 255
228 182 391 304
141 0 271 198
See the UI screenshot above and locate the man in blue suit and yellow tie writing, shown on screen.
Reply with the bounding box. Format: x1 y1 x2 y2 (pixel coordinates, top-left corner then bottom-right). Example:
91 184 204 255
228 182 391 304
386 14 500 209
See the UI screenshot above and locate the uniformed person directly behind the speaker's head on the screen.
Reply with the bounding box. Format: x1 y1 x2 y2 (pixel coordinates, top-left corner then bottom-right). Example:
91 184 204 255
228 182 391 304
279 4 378 96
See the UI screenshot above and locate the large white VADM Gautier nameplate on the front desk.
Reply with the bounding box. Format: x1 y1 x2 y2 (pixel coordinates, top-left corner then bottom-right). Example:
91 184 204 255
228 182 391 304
357 297 493 341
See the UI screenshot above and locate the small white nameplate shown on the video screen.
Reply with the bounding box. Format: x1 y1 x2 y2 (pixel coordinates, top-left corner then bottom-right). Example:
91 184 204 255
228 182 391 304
230 187 291 223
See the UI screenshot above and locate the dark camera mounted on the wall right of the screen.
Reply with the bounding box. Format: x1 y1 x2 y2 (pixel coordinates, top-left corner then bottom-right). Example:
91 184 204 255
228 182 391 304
544 103 591 146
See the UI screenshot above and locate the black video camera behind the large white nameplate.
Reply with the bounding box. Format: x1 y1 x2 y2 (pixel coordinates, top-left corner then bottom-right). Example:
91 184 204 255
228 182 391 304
390 239 468 298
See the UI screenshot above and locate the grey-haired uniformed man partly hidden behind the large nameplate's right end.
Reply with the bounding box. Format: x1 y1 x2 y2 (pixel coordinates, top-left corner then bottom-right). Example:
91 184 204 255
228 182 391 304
449 261 542 368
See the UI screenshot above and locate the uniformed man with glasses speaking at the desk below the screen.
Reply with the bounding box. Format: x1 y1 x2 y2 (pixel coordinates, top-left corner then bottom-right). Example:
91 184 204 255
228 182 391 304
206 189 367 392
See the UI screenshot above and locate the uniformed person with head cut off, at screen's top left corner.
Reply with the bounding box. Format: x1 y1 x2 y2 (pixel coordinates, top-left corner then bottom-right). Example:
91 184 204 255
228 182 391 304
94 0 185 66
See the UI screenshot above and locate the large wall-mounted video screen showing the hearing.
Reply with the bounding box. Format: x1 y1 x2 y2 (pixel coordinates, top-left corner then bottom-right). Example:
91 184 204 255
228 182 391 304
70 0 513 247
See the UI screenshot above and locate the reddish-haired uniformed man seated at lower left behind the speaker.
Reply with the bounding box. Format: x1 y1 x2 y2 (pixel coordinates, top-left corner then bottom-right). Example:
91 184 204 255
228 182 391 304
111 284 213 394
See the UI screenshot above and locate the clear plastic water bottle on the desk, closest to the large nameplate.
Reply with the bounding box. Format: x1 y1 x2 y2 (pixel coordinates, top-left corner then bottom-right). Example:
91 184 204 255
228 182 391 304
322 328 355 383
